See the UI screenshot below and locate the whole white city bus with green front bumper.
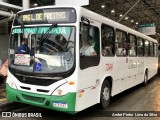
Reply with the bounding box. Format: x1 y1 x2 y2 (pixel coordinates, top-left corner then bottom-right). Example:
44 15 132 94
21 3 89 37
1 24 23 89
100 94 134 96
6 6 158 114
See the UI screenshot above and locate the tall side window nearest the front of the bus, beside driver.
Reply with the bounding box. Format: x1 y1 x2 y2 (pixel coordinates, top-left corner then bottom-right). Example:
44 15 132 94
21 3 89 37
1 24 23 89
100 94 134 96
79 23 100 69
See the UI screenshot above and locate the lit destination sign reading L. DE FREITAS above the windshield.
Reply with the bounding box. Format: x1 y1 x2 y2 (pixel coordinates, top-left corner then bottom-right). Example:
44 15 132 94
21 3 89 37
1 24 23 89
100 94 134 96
13 8 76 25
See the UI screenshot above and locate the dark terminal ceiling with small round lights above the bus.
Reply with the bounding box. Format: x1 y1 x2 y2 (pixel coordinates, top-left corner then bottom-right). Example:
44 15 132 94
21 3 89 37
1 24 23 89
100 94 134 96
0 0 160 38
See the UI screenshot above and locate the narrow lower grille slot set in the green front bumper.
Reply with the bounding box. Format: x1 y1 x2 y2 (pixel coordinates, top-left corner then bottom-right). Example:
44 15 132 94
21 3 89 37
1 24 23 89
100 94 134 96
22 94 45 103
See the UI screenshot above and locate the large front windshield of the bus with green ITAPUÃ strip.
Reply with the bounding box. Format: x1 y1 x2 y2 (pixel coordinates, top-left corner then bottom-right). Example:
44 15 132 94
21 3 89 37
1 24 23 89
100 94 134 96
10 26 75 75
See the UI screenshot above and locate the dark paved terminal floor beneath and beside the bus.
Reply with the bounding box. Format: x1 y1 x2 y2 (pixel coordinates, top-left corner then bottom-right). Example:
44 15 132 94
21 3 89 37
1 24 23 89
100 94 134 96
1 74 160 120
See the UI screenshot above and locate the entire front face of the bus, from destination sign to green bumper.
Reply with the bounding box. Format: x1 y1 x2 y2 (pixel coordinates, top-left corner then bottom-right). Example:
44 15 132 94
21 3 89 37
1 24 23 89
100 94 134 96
6 7 76 111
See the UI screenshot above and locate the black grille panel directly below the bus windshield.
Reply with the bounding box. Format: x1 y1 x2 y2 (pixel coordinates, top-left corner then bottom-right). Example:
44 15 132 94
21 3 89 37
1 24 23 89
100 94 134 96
15 75 58 86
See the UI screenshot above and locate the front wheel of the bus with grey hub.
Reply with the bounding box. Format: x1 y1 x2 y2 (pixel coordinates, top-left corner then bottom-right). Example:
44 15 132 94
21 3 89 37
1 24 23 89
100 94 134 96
100 80 111 109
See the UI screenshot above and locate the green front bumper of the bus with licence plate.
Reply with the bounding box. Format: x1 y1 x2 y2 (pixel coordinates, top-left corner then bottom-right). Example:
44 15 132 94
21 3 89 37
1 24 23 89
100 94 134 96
6 84 76 114
